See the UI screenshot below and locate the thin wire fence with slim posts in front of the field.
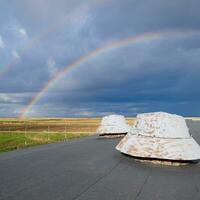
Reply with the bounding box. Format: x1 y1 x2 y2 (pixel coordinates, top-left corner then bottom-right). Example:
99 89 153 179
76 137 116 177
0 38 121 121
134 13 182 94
0 123 99 150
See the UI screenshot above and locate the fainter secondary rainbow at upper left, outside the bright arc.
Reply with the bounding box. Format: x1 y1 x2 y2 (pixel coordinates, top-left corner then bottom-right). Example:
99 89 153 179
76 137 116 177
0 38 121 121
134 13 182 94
0 0 105 79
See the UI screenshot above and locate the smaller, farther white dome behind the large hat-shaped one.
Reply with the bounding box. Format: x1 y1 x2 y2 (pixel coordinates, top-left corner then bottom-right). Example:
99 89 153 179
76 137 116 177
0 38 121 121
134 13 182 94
96 115 130 136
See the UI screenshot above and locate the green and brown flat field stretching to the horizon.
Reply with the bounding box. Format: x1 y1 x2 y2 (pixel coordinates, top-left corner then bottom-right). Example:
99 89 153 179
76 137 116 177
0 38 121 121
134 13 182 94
0 118 134 152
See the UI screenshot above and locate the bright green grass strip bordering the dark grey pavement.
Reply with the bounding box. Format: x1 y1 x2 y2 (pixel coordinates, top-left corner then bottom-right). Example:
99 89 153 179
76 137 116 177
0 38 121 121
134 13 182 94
0 132 89 152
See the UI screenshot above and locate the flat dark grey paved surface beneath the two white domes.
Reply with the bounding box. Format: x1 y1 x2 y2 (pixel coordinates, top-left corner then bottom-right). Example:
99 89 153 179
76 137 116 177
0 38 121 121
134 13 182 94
0 122 200 200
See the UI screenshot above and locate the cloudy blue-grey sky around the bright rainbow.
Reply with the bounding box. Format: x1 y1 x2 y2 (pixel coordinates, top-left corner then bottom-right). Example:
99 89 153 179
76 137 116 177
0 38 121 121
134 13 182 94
0 0 200 117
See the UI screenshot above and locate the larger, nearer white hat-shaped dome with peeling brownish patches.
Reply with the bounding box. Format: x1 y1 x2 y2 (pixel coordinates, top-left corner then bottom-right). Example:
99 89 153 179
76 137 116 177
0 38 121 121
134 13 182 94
116 112 200 161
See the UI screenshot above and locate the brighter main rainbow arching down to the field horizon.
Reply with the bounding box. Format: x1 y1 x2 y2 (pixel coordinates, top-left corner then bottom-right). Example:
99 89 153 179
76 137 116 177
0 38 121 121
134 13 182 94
20 30 200 117
